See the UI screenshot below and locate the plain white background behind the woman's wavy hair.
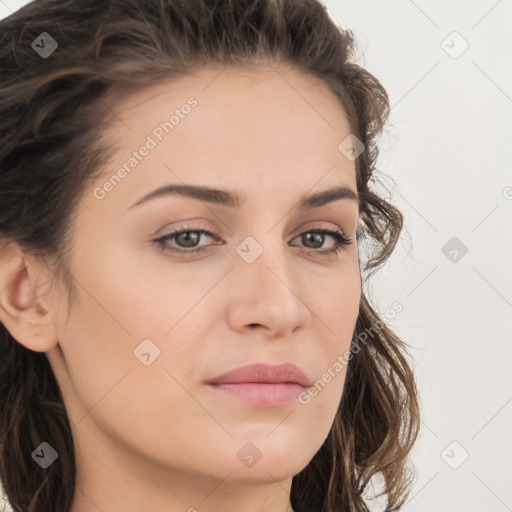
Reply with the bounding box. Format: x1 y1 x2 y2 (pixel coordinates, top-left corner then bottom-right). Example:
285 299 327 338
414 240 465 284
0 0 512 512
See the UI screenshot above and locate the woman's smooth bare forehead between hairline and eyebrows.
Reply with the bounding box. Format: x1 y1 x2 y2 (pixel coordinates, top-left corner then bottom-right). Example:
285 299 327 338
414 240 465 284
92 66 355 212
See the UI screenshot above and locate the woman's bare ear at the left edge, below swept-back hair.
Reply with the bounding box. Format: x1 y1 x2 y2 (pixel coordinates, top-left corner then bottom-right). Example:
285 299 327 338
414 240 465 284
0 242 58 352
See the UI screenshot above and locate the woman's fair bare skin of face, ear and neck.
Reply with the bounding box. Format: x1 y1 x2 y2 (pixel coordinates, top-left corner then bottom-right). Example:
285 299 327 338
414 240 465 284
0 65 361 512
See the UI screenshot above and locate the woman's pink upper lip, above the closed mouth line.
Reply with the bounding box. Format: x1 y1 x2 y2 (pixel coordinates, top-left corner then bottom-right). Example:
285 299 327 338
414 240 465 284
207 363 309 387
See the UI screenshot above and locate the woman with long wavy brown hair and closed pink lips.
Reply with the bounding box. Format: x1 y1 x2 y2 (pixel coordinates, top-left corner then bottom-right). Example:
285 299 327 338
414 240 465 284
0 0 419 512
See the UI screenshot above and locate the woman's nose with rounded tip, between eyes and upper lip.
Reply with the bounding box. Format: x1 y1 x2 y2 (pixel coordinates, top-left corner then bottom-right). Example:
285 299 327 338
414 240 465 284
228 236 312 338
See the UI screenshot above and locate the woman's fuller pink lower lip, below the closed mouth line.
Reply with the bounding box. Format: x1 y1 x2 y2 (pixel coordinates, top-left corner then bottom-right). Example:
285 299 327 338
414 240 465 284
208 382 306 407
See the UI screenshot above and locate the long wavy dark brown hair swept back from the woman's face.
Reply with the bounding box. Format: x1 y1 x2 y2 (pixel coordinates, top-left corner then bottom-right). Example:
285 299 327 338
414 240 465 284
0 0 420 512
